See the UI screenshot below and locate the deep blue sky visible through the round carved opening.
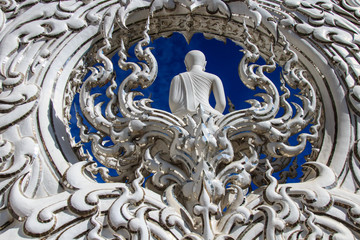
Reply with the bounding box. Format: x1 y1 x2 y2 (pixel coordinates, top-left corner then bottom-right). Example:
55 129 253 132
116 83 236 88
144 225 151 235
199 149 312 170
70 33 311 185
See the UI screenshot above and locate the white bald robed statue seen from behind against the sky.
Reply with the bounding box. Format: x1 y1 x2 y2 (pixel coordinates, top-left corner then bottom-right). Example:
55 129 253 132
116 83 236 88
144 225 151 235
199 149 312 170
169 50 226 118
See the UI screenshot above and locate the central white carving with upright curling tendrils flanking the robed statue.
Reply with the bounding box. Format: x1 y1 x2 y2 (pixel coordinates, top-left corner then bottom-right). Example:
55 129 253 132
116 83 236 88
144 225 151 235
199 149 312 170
69 12 321 239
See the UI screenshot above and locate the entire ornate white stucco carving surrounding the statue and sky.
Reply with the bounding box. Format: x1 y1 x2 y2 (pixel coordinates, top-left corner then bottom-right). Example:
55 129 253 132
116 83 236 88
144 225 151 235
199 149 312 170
0 0 360 239
